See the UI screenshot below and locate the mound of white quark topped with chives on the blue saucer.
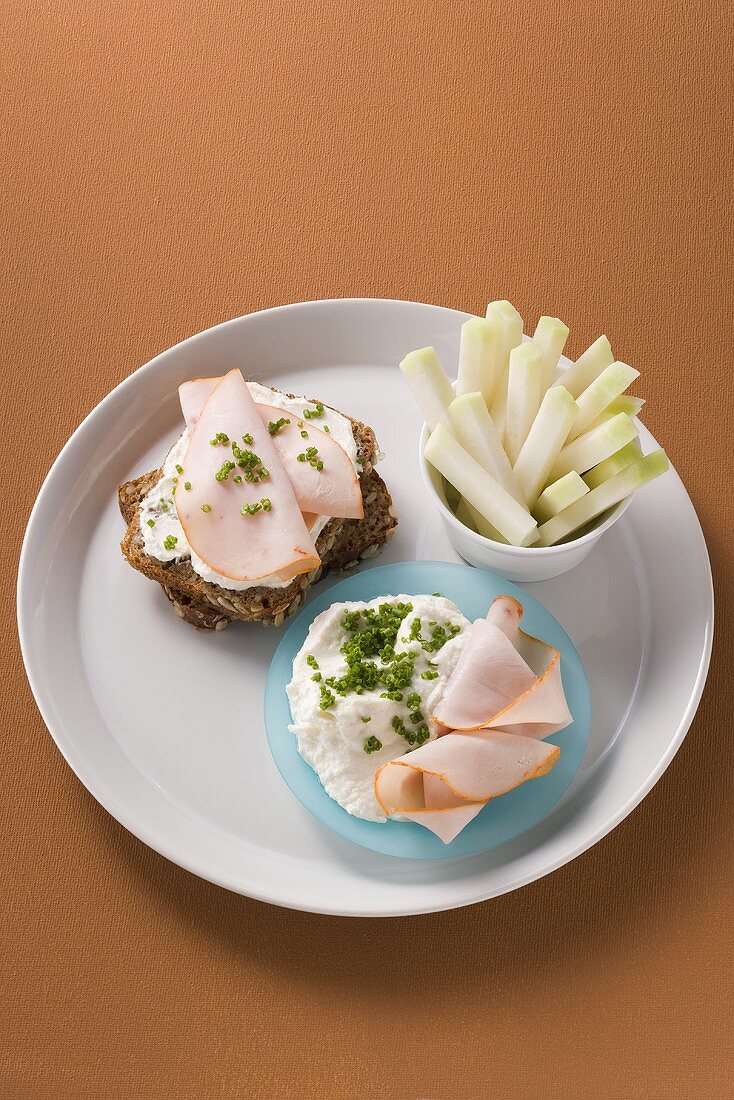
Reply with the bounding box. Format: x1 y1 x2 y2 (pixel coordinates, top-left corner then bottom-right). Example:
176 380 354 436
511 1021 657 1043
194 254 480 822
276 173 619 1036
287 595 471 822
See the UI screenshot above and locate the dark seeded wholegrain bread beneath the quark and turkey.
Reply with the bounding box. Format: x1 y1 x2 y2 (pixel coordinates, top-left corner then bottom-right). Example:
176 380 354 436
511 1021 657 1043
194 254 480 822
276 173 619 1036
118 395 397 630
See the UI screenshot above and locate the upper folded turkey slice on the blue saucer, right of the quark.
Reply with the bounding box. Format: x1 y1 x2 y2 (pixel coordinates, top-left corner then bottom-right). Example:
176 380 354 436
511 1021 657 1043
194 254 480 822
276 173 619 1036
434 596 573 738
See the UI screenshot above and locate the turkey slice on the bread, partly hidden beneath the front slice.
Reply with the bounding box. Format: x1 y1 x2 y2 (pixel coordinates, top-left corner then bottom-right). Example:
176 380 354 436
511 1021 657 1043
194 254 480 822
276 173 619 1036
178 378 364 519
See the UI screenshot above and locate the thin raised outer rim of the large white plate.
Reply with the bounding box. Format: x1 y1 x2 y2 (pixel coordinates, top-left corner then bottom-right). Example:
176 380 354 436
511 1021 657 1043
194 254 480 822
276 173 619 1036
15 297 715 917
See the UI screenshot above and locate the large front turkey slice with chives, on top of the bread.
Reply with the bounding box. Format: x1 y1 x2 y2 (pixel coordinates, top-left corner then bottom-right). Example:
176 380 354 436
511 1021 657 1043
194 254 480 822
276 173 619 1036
175 370 320 583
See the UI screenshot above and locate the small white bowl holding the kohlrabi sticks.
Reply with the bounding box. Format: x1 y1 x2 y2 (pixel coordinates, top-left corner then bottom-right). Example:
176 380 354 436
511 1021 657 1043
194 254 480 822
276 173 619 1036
418 424 632 582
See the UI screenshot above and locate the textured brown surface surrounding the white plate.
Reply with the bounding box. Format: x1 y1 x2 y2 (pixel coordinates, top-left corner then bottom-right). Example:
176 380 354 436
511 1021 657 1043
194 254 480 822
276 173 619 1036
0 0 734 1100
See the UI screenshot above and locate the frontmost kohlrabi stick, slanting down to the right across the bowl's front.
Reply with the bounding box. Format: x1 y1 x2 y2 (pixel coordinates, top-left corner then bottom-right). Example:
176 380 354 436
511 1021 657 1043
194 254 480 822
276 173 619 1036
425 424 537 547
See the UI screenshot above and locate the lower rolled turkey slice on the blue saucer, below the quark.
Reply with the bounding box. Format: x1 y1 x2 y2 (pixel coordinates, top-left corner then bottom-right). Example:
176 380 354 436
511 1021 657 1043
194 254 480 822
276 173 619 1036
374 729 560 844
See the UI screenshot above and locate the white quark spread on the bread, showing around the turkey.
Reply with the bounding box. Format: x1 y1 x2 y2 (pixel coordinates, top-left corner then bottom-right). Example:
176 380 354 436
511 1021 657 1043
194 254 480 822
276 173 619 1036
140 382 360 592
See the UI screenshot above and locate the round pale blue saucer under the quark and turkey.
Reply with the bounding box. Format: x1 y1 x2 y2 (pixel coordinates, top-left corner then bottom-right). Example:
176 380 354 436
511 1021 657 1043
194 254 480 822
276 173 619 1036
264 561 591 859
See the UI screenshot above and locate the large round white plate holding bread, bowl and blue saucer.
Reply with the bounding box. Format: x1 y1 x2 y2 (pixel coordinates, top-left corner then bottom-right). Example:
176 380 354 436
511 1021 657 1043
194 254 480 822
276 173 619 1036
18 299 713 916
